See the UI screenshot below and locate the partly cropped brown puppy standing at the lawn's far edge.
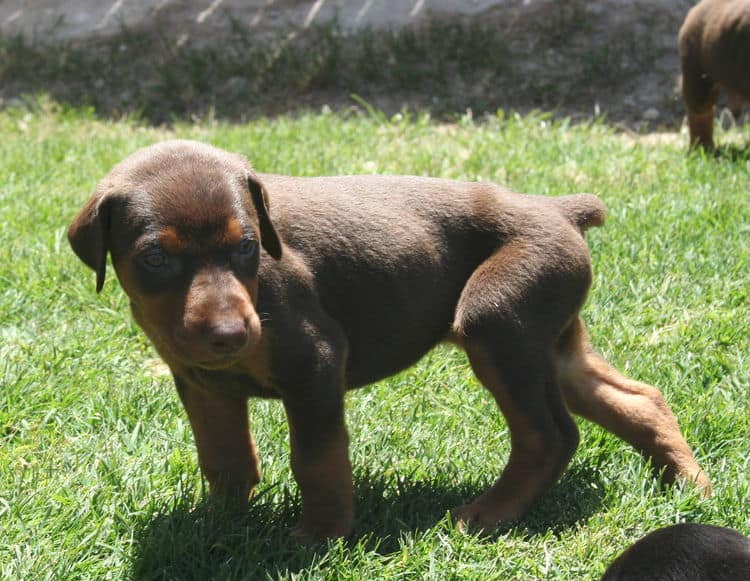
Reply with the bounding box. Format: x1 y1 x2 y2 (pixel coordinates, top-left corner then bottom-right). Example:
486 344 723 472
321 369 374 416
679 0 750 149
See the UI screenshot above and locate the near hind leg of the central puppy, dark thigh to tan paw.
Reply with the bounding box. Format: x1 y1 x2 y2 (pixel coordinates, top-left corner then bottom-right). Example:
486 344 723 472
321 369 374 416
453 244 588 529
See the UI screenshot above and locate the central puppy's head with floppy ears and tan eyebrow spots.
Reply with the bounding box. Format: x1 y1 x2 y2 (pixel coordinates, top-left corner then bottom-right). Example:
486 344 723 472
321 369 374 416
68 141 282 368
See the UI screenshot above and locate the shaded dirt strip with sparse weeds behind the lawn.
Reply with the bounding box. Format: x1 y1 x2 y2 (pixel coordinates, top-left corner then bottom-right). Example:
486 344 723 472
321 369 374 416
0 0 724 130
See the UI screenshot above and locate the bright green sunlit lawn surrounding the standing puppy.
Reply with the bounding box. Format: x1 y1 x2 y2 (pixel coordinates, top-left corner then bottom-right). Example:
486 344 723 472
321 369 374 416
0 101 750 580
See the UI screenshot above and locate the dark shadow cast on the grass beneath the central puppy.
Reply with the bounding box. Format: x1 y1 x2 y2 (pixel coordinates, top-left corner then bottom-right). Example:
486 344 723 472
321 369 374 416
133 466 604 580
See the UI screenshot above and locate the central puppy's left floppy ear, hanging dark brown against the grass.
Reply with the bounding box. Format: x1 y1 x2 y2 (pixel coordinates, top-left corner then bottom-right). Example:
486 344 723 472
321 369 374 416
68 193 110 292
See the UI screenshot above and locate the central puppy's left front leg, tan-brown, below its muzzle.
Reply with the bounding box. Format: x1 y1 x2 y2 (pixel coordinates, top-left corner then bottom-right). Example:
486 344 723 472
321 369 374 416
175 377 260 509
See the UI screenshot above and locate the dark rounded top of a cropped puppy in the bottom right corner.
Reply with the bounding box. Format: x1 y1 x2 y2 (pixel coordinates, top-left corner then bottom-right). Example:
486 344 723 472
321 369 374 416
602 523 750 581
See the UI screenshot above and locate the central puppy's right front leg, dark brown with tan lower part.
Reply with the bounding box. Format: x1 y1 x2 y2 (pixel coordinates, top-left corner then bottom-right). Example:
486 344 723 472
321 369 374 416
284 394 354 541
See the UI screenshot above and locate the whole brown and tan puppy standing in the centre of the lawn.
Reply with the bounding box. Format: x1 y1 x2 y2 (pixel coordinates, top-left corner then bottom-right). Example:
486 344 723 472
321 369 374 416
68 141 710 539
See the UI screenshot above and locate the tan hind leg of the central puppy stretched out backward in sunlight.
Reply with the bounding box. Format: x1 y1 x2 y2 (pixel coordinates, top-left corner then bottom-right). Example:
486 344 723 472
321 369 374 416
558 318 711 496
